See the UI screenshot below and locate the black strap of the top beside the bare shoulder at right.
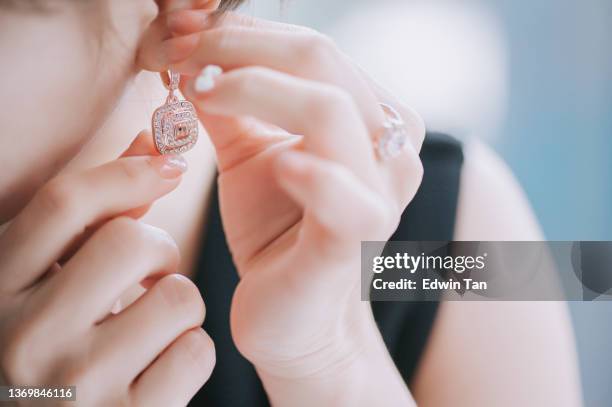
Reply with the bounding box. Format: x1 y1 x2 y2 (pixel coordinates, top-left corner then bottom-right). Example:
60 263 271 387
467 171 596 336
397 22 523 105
372 133 463 383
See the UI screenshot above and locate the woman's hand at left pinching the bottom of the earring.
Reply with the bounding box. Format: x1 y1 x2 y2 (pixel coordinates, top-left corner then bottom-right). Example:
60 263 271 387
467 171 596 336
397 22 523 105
0 134 215 406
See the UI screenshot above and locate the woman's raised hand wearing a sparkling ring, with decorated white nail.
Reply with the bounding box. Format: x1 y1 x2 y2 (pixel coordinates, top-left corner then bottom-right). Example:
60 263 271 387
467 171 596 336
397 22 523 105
168 11 424 405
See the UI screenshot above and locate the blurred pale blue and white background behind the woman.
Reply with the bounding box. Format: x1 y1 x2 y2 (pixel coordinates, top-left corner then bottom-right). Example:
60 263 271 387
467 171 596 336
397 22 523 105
244 0 612 406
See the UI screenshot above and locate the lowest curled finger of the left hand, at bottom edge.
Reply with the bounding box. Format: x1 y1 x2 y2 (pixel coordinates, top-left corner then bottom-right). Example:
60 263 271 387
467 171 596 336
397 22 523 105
130 328 216 407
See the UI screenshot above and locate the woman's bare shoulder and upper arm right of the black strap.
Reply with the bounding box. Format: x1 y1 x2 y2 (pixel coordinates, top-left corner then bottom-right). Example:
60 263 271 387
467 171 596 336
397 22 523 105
413 142 580 406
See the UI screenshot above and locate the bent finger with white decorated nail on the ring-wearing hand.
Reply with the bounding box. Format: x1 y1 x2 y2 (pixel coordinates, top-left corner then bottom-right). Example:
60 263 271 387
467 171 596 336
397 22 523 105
185 68 376 182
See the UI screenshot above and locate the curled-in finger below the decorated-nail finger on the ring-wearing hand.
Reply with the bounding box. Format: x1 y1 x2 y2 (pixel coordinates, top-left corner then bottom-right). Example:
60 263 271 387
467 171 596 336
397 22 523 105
275 151 400 247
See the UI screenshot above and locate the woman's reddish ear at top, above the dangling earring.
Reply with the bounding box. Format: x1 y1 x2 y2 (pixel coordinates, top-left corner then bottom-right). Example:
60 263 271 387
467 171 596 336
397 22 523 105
136 0 221 72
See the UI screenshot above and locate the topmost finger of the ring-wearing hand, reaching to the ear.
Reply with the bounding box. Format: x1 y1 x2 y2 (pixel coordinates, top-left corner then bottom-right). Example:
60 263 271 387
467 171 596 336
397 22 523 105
173 25 384 131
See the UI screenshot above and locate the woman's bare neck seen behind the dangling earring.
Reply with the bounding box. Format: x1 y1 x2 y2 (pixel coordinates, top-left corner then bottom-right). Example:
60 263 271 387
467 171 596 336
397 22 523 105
66 72 216 274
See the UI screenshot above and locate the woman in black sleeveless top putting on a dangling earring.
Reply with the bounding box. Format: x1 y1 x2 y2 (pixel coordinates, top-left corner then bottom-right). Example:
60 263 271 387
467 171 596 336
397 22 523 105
0 0 580 406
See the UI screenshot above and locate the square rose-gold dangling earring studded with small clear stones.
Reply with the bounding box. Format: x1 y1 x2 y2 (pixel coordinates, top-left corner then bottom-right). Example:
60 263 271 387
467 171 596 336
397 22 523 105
151 71 198 154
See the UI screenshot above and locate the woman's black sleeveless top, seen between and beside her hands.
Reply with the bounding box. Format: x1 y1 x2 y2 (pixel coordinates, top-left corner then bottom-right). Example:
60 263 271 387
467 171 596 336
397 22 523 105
190 133 463 407
